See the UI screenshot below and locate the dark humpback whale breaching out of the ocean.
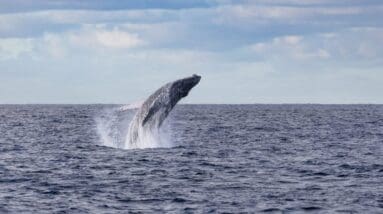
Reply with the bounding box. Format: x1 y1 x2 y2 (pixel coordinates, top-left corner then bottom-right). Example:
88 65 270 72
126 74 201 148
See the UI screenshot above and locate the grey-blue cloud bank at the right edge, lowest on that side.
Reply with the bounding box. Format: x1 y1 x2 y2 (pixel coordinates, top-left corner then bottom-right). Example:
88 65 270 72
250 28 383 63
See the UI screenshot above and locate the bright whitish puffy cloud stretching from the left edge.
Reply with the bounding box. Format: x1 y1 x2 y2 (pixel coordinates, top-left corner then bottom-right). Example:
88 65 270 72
0 25 146 60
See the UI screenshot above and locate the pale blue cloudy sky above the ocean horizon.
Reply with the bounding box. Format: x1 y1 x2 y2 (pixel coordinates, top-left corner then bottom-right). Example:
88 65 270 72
0 0 383 104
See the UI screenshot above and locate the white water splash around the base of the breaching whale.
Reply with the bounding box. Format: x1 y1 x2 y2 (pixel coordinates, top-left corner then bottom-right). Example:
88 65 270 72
95 105 173 149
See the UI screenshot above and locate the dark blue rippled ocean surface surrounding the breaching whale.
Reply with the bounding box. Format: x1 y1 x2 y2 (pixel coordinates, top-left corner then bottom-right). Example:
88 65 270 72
0 105 383 213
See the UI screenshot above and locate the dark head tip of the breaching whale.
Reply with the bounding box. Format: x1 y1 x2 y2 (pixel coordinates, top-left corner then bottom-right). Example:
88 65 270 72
170 74 201 102
